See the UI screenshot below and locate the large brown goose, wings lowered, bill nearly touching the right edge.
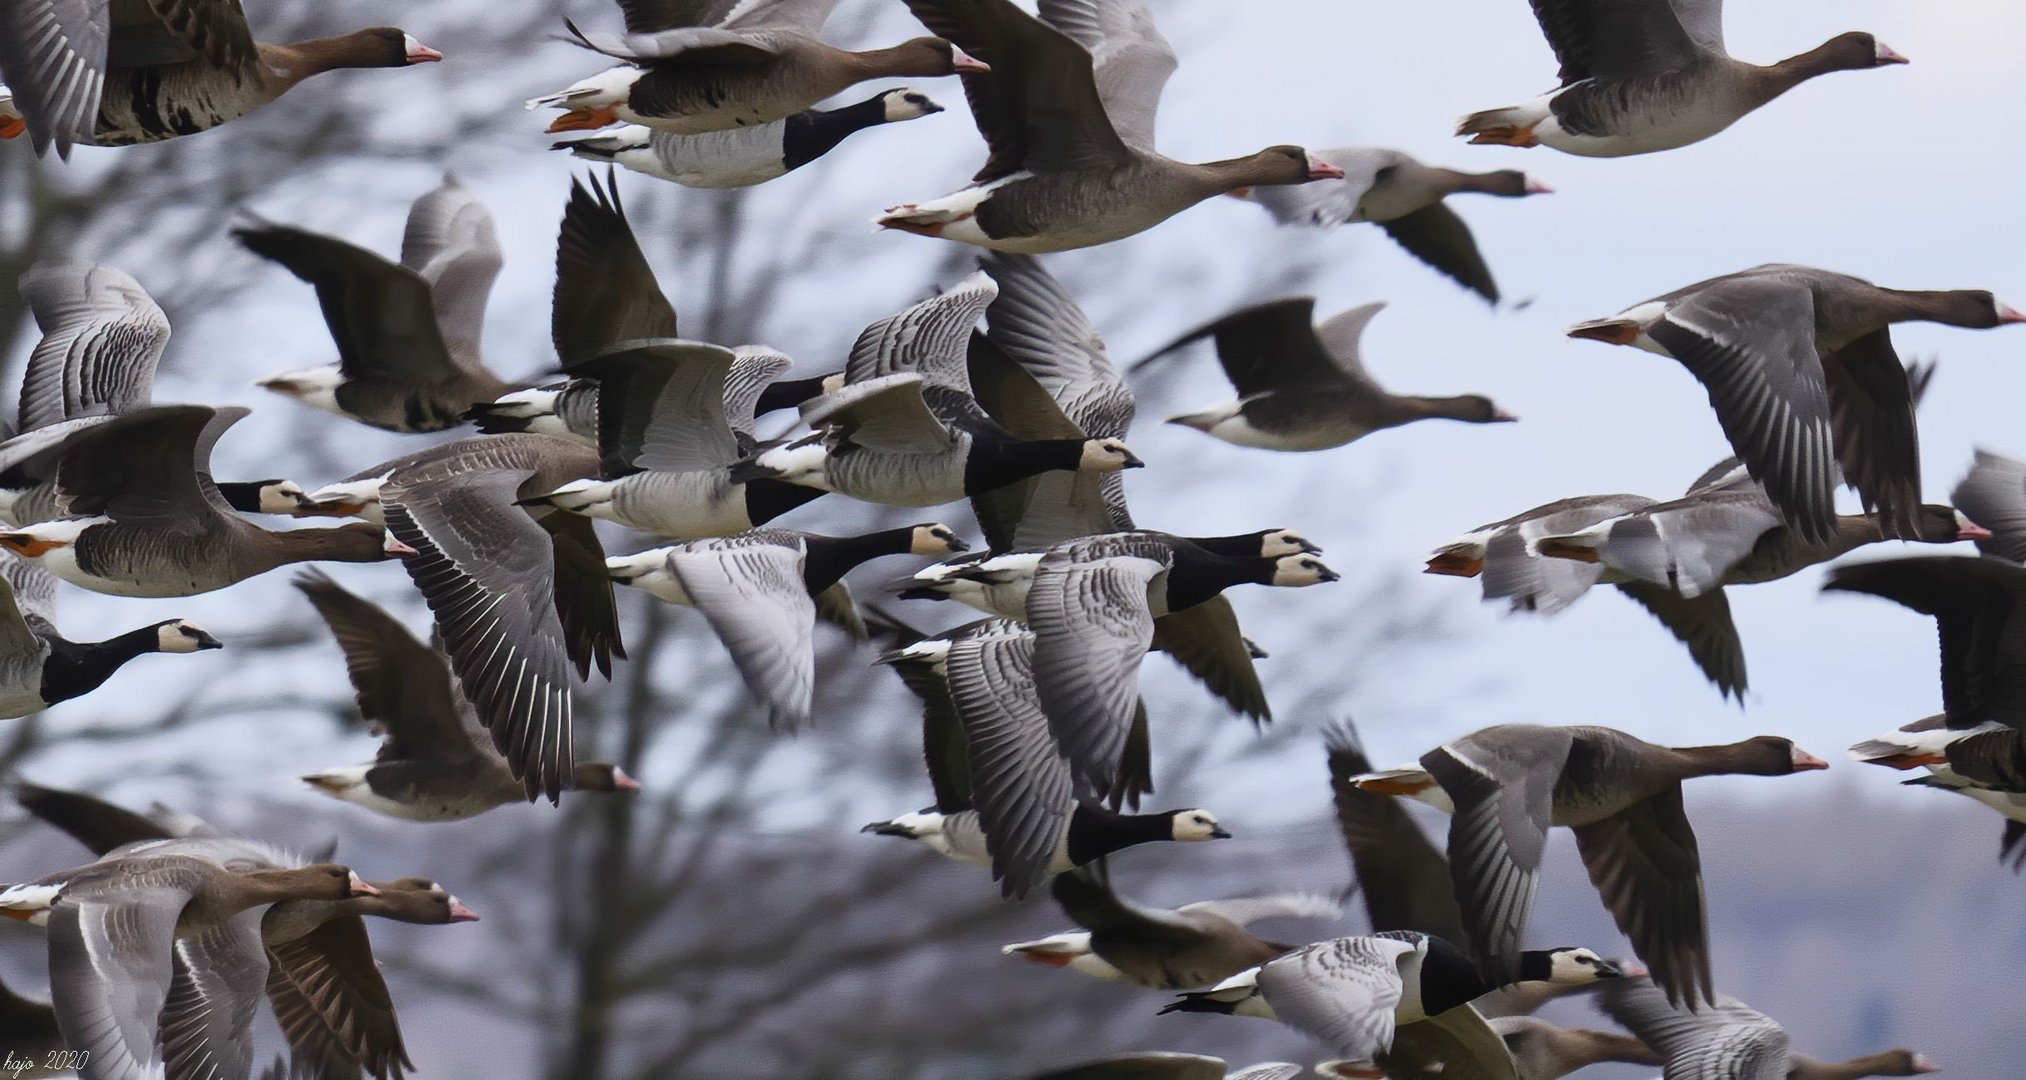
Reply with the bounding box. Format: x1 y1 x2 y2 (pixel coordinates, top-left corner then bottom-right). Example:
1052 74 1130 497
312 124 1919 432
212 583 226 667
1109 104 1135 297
1568 263 2026 541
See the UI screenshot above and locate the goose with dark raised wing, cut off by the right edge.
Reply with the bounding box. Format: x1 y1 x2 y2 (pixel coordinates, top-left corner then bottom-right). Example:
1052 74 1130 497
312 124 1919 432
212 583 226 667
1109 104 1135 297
1823 555 2026 826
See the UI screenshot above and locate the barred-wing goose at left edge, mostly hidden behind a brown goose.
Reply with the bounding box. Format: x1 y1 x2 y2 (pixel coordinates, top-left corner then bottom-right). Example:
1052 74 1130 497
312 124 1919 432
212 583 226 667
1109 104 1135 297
0 261 302 527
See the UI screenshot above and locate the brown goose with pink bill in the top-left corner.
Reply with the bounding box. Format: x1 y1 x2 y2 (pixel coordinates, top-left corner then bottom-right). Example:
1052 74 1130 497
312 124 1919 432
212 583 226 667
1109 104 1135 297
0 0 444 158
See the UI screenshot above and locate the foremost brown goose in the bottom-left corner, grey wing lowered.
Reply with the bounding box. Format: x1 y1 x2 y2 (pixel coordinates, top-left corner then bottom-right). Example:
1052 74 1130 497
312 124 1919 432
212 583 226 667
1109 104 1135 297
0 841 377 1076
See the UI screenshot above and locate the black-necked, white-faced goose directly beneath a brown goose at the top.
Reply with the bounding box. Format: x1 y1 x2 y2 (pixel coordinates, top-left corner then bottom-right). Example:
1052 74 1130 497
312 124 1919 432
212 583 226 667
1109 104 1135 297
551 87 942 188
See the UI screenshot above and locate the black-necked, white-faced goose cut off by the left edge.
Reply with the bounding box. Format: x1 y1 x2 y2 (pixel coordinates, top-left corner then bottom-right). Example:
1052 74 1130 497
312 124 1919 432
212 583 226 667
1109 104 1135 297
0 559 223 717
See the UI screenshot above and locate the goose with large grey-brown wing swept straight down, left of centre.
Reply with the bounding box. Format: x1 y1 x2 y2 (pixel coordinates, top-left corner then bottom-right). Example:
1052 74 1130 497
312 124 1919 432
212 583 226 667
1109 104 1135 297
367 434 626 802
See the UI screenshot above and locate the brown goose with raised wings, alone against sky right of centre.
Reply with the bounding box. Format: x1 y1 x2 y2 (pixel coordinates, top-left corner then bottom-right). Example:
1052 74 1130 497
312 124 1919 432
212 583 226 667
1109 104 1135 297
1135 296 1517 450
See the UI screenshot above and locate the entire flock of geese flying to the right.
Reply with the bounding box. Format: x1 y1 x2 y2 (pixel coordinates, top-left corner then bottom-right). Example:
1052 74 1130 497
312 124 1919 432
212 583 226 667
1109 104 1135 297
0 0 2026 1080
